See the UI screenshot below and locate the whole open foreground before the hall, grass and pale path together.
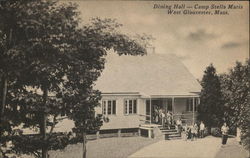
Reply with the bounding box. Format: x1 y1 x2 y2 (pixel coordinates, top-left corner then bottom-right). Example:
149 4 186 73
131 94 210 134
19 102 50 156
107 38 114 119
12 136 249 158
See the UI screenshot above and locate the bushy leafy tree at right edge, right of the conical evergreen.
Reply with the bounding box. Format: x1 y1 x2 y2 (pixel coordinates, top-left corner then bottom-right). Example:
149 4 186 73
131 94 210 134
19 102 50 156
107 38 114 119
221 59 250 152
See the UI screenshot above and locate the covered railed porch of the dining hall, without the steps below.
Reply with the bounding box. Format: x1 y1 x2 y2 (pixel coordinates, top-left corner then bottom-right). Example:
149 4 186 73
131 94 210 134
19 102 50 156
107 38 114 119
140 95 200 126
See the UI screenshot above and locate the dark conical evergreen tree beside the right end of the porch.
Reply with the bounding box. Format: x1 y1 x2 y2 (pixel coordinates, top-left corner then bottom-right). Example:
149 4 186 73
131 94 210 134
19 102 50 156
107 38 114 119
198 64 224 128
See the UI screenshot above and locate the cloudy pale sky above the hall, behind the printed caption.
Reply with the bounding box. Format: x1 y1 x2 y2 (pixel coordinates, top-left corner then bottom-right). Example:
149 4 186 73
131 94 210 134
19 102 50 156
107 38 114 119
74 1 249 79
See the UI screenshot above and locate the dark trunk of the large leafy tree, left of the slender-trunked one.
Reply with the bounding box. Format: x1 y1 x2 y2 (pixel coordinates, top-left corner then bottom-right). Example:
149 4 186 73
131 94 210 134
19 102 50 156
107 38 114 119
40 88 48 158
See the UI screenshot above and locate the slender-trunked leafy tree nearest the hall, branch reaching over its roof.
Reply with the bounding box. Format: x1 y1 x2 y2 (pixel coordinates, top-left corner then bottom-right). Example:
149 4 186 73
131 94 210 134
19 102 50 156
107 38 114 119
56 18 150 157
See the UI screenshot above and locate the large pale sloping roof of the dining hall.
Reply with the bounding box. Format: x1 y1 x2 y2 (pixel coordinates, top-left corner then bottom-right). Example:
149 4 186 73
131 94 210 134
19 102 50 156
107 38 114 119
95 53 201 95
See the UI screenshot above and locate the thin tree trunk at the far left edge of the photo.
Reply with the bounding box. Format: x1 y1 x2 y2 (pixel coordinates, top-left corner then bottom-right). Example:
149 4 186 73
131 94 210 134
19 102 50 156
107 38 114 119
0 75 8 136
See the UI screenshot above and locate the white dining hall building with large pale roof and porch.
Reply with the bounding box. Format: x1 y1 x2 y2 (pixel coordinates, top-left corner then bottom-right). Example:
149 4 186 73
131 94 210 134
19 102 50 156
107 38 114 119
95 53 201 137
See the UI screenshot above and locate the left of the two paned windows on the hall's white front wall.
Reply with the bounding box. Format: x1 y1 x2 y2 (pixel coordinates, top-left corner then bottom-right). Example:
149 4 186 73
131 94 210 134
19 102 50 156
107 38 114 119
102 100 116 115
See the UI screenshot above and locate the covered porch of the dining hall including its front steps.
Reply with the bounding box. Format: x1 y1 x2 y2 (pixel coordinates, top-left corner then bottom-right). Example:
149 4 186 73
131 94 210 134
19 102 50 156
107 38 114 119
139 95 200 140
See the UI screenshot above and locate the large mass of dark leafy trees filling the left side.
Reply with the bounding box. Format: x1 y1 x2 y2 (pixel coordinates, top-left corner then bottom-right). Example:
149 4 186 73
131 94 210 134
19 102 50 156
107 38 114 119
0 0 148 158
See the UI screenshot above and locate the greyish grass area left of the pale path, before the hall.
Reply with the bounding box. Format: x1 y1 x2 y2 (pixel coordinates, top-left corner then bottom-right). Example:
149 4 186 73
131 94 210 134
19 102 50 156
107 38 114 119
47 137 158 158
